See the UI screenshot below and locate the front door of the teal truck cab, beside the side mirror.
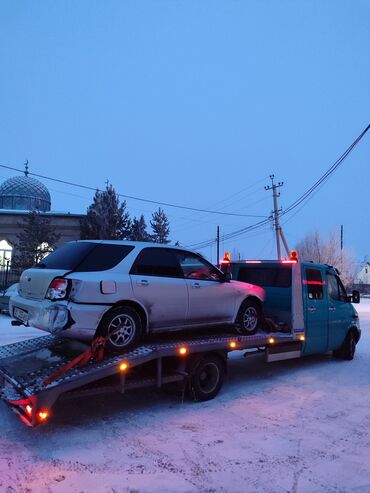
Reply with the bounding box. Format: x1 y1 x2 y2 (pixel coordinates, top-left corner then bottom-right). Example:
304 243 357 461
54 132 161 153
326 272 351 350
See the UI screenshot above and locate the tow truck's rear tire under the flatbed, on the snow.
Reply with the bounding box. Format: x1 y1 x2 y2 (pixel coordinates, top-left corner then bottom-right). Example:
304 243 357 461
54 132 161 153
190 354 225 401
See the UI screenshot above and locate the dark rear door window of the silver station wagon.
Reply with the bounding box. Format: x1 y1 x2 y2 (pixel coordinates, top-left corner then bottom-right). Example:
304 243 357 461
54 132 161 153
130 248 183 277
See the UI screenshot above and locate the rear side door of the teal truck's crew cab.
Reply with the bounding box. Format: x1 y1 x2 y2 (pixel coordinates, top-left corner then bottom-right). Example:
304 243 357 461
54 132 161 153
303 267 329 354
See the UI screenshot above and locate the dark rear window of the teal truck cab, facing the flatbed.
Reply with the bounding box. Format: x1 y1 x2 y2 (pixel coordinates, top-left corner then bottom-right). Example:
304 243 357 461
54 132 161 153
238 266 292 288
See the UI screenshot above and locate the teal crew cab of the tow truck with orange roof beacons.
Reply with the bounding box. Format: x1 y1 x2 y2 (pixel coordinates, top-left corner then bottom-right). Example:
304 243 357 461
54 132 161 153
221 258 361 359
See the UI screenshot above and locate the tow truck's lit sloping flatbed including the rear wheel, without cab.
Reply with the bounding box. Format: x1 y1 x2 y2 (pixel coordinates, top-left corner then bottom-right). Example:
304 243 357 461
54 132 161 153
0 331 301 426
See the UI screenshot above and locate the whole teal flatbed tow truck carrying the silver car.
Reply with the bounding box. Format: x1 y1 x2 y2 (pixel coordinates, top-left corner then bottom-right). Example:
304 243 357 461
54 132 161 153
0 261 361 426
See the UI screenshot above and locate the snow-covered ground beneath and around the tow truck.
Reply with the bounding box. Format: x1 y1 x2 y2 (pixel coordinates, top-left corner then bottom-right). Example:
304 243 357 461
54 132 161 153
0 300 370 493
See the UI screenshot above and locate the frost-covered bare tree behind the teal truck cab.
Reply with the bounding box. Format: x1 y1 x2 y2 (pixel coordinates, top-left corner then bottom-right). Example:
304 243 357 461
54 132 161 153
296 231 356 286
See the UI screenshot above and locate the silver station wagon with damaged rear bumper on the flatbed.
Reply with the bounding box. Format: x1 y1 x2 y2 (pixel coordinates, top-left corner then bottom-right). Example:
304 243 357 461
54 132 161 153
9 240 264 350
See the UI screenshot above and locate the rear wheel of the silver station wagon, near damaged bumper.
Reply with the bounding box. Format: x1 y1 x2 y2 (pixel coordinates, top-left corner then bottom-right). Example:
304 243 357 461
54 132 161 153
96 306 142 352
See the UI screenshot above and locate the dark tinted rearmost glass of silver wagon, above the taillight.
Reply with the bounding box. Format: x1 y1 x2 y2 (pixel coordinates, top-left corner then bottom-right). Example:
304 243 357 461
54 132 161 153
35 242 134 272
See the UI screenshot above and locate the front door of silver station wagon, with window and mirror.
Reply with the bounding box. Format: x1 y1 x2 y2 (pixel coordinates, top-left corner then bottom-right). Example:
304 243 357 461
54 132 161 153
177 251 236 324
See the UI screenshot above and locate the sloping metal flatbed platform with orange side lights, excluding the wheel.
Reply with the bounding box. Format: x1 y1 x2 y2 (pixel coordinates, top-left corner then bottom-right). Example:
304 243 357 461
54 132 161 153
0 332 300 426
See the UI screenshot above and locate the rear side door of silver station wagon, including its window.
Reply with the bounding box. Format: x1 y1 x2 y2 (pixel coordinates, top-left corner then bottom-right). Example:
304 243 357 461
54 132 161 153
130 247 188 331
